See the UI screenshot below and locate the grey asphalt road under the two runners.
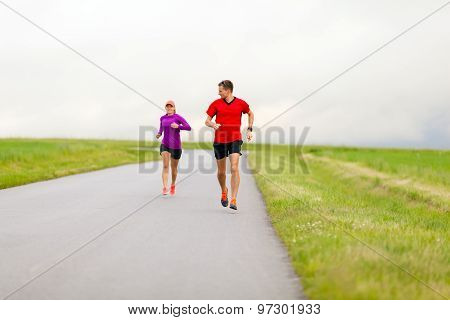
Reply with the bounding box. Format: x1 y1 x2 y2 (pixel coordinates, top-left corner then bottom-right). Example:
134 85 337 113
0 150 304 299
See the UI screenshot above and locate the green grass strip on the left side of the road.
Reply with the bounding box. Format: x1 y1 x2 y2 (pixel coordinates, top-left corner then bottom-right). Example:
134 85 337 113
0 139 159 189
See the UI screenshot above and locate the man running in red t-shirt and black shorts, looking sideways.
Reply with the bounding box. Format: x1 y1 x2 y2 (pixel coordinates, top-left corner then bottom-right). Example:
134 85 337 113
205 80 254 210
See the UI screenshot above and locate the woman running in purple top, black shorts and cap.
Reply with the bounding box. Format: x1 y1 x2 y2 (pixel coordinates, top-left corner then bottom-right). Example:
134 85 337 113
156 100 191 195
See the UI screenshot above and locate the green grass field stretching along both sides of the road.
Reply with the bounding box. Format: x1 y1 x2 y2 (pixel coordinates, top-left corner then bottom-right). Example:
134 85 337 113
0 139 450 299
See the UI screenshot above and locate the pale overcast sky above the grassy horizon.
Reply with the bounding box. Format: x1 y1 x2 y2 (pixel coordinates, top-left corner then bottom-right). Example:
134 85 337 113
0 0 450 148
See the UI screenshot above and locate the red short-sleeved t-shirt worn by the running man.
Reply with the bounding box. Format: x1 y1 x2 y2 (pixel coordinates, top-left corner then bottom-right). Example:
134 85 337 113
206 97 250 143
